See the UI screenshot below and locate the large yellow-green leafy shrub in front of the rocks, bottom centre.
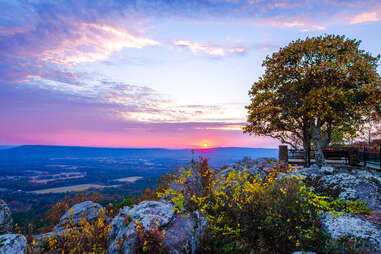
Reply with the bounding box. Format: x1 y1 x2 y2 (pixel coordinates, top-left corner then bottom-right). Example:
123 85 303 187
194 170 325 253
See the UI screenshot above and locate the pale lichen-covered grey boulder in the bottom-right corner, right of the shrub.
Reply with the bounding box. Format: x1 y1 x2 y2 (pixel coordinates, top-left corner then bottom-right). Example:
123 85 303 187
320 212 381 253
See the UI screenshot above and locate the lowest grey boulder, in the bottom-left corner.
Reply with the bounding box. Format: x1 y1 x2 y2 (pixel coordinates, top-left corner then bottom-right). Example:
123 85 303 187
0 234 27 254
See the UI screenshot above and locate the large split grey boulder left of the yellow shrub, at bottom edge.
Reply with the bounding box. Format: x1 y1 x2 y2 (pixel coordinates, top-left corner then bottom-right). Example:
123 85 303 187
109 200 206 254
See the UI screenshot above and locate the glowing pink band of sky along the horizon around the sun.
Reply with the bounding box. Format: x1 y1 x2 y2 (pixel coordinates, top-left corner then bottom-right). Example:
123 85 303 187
0 125 279 148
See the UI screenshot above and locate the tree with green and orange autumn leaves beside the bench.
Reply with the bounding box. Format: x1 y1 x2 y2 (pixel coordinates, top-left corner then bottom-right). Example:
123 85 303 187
244 35 381 166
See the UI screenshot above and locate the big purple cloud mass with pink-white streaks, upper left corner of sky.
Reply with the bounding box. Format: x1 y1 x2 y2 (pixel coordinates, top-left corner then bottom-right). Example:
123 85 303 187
0 0 160 82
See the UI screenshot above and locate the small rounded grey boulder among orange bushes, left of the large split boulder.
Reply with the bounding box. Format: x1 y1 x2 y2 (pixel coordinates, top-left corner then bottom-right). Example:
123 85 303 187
55 201 102 231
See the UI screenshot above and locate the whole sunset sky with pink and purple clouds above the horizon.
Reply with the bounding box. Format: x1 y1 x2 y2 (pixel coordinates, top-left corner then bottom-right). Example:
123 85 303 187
0 0 381 148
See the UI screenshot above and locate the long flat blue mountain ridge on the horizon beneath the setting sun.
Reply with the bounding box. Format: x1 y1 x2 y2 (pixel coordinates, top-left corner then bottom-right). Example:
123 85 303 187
0 145 278 166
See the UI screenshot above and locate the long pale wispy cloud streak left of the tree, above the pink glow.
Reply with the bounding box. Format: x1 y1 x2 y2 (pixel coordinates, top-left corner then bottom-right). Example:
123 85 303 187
22 77 243 123
